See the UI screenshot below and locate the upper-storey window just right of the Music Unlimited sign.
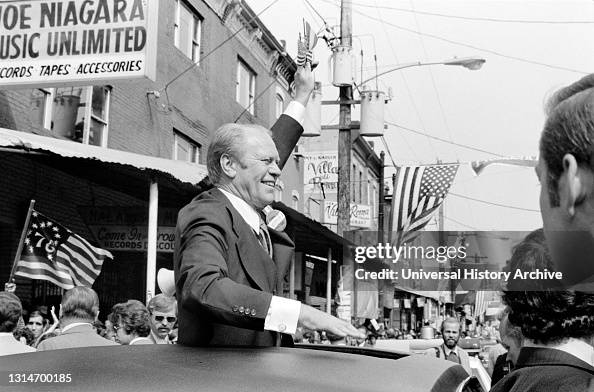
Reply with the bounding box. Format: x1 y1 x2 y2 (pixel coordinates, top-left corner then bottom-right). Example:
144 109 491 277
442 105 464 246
174 0 202 63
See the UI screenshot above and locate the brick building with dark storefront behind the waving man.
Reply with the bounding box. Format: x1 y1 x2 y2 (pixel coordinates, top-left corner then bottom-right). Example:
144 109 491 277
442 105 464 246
0 0 299 309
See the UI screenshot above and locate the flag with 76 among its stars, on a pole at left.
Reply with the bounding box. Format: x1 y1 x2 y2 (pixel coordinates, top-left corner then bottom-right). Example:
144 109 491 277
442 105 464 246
15 210 113 290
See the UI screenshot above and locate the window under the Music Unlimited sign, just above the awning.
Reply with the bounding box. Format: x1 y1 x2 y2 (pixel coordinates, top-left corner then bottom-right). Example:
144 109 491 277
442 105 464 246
31 86 111 147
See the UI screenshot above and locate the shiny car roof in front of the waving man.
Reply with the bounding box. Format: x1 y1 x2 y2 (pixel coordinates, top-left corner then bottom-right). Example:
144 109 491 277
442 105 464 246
0 345 467 392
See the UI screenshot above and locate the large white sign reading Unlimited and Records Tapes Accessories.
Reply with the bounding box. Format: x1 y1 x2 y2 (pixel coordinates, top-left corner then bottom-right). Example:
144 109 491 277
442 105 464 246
0 0 159 88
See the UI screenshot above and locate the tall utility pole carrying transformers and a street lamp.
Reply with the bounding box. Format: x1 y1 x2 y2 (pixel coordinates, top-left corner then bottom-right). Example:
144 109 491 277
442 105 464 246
337 0 353 236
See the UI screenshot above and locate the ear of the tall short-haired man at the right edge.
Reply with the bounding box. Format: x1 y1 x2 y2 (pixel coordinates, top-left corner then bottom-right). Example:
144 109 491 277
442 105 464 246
559 154 589 217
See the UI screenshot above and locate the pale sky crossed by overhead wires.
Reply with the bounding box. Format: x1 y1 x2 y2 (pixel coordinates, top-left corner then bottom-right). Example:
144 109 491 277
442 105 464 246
247 0 594 230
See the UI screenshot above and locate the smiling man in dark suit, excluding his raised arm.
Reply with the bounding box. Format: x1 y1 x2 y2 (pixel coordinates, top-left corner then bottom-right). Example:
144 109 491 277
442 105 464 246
174 74 360 346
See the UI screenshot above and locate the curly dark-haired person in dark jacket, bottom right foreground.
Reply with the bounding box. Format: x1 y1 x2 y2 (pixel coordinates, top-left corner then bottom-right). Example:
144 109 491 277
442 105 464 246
492 229 594 392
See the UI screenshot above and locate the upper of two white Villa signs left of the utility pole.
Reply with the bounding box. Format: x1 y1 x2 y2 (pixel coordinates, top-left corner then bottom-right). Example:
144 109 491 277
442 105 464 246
303 151 338 193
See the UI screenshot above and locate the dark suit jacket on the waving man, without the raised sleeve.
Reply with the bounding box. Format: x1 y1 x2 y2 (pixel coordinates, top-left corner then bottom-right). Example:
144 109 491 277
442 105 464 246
174 188 294 346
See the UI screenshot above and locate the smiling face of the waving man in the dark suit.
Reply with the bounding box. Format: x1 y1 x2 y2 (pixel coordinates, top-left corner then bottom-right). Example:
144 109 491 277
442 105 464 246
232 129 281 209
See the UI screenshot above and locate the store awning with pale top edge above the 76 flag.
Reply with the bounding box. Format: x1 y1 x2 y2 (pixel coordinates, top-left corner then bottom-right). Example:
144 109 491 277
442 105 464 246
0 128 206 204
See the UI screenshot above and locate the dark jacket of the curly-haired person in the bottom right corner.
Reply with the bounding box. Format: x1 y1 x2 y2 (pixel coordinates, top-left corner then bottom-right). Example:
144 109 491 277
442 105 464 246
491 347 594 392
